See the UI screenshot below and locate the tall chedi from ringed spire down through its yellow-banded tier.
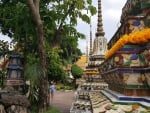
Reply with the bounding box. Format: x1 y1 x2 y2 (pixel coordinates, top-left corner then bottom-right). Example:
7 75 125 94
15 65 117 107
86 0 107 83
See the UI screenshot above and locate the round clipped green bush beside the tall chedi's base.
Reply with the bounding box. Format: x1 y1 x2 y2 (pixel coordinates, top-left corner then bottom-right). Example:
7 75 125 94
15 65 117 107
71 64 83 79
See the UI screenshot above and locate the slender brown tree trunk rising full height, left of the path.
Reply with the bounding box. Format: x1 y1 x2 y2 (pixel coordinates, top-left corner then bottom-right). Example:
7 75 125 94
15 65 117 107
27 0 49 113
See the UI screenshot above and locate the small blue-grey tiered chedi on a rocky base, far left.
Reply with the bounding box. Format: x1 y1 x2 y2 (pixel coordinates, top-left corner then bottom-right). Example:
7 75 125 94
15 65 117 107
0 53 30 113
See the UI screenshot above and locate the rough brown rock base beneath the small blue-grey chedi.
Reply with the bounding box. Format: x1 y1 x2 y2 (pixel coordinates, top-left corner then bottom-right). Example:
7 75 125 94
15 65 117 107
0 87 30 113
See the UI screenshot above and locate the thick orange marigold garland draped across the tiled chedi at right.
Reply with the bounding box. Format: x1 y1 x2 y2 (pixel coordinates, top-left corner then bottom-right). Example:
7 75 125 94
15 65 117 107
105 28 150 59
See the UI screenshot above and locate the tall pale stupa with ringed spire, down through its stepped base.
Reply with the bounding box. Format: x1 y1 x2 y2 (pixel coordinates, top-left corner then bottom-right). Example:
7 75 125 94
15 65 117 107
70 0 108 113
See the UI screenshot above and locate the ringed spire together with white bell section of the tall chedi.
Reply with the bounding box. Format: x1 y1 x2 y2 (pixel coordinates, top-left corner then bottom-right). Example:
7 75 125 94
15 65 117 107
93 0 107 56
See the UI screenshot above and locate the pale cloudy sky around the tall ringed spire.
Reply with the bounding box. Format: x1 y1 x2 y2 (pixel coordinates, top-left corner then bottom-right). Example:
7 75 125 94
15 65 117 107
77 0 127 53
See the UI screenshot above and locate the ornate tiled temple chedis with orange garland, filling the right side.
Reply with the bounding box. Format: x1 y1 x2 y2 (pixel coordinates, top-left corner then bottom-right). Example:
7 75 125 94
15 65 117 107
70 0 150 113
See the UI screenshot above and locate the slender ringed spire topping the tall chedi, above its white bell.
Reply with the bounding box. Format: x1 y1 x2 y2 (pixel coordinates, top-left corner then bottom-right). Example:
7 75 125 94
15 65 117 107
96 0 105 36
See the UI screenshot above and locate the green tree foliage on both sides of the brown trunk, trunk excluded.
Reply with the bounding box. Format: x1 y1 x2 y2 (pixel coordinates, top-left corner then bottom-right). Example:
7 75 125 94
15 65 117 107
0 0 96 110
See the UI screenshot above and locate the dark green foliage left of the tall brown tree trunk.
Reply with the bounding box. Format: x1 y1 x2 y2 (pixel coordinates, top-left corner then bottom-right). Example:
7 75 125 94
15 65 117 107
0 0 38 57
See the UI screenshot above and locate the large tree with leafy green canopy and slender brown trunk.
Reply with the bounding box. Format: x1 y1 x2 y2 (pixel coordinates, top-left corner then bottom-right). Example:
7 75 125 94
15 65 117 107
0 0 96 112
